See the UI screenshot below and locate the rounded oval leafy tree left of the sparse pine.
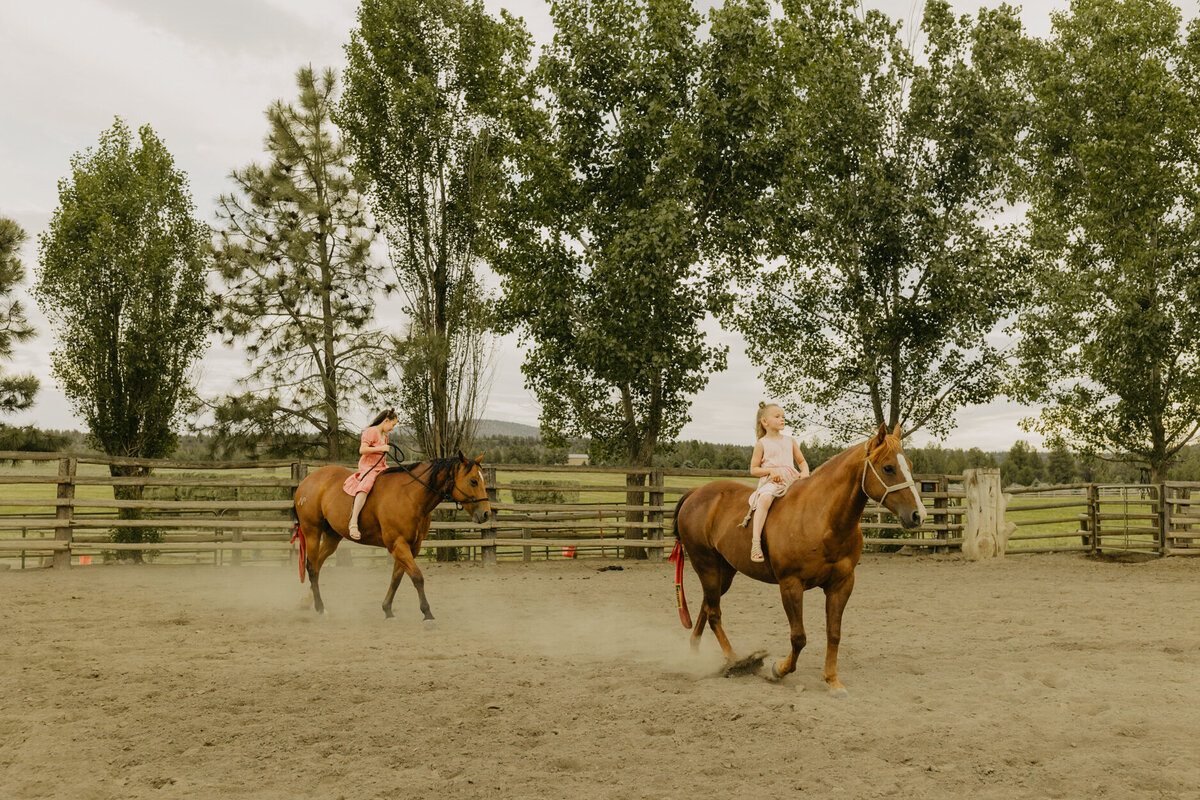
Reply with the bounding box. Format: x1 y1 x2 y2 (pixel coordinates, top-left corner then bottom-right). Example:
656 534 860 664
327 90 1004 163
35 119 211 560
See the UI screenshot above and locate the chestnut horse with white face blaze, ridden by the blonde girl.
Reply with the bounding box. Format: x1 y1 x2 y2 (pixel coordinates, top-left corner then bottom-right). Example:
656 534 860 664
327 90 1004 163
672 425 925 696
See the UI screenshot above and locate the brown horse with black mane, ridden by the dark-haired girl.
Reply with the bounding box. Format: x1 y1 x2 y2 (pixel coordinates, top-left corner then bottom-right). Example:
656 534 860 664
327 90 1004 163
292 453 492 620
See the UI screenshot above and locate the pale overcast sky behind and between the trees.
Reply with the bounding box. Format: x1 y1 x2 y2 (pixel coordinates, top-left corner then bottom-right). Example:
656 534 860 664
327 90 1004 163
0 0 1196 450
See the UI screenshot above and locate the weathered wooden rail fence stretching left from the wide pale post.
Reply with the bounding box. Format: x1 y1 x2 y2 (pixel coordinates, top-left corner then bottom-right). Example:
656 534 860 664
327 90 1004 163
0 452 965 567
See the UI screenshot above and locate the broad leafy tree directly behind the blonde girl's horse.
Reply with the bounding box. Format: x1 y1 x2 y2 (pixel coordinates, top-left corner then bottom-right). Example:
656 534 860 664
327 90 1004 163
698 0 1026 438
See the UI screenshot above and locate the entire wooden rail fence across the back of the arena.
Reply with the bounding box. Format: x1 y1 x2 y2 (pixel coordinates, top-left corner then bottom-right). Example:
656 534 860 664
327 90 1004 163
0 452 1200 567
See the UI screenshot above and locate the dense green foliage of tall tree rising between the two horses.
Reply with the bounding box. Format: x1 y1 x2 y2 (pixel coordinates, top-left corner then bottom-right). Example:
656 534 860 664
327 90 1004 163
493 0 725 464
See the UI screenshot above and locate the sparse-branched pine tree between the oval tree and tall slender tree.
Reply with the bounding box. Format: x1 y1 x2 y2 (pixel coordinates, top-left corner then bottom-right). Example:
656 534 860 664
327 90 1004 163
215 67 391 461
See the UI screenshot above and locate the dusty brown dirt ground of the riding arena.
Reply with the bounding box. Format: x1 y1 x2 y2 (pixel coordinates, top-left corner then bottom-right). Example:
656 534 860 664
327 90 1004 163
0 555 1200 800
